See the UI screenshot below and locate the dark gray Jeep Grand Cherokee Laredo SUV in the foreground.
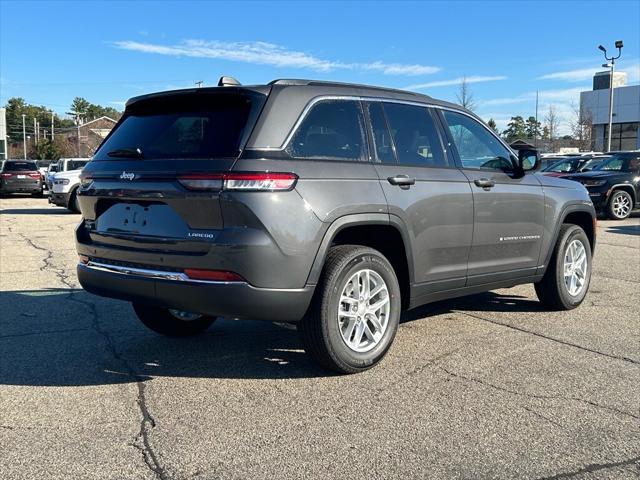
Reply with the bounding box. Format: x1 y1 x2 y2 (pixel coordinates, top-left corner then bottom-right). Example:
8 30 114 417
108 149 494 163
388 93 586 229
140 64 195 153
76 79 595 373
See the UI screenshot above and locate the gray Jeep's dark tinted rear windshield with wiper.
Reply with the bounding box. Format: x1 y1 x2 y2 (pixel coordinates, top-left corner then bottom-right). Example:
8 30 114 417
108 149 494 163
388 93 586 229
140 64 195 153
94 92 266 160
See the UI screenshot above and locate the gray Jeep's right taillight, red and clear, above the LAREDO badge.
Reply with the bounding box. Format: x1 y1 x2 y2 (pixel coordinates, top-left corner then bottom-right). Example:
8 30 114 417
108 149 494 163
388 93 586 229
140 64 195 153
178 172 298 192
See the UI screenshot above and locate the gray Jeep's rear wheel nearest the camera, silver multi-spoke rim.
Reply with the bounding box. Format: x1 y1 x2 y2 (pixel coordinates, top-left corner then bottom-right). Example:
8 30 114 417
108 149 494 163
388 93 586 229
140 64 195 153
300 245 401 373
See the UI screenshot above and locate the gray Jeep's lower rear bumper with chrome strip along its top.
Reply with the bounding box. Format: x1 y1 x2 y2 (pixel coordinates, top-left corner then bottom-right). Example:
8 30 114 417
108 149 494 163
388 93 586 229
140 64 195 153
77 264 314 322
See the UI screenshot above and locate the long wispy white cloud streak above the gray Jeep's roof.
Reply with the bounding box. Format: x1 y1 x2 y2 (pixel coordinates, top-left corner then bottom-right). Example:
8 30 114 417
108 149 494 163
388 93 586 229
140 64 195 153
115 40 441 76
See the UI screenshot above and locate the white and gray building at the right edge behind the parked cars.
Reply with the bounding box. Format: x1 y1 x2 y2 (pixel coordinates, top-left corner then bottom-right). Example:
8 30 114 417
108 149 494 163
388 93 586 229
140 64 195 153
580 71 640 152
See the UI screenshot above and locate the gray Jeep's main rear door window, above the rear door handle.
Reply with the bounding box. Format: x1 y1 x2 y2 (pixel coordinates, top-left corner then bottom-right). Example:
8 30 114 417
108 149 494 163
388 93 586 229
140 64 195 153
384 103 449 167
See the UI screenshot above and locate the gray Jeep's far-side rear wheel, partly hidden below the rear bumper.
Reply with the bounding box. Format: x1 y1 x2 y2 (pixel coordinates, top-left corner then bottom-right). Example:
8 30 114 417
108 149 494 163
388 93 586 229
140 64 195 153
132 303 216 337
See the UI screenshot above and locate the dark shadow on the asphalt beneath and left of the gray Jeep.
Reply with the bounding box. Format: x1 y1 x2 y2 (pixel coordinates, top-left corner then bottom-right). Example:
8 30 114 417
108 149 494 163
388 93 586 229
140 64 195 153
0 289 540 386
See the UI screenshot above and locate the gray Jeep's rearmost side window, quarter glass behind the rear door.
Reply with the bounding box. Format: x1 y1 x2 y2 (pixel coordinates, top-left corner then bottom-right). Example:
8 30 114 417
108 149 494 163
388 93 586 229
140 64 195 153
287 100 365 161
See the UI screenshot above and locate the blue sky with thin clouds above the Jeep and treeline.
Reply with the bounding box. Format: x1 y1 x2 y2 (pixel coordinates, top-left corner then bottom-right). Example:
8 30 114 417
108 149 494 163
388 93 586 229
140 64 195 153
0 0 640 131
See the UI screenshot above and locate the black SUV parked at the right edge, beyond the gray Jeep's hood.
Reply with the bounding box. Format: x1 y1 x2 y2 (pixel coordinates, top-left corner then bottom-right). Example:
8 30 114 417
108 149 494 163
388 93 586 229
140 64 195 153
563 151 640 220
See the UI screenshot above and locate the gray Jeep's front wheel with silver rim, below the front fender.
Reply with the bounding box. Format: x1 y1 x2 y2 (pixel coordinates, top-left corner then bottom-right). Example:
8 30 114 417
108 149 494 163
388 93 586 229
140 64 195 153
534 224 592 310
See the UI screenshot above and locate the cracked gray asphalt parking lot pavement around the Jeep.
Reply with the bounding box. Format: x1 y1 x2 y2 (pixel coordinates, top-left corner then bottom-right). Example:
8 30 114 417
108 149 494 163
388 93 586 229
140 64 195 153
0 197 640 480
